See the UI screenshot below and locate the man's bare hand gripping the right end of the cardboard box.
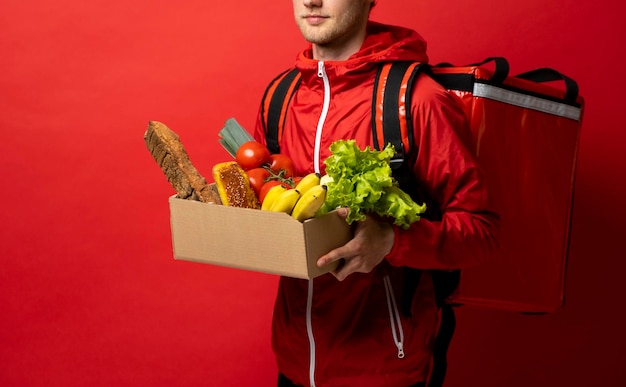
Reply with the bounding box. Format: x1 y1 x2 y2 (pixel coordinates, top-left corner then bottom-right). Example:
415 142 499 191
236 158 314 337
317 208 394 281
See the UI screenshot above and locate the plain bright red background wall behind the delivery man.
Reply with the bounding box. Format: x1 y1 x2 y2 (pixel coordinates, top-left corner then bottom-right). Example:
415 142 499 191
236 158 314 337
0 0 626 387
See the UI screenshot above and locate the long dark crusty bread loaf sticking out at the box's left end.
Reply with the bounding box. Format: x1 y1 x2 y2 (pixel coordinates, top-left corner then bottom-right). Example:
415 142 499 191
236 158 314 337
144 121 221 204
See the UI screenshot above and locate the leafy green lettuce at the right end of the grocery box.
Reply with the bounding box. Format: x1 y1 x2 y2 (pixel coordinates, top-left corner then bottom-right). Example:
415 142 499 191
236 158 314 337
320 140 426 228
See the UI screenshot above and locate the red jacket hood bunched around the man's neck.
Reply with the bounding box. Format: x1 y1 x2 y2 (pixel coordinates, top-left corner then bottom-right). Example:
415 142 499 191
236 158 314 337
296 21 428 71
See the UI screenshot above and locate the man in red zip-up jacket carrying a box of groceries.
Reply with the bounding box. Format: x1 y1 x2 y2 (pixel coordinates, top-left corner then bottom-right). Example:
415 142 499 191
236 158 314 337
255 0 497 387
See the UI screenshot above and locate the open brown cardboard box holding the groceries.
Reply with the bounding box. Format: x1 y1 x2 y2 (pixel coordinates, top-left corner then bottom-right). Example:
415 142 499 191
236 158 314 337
169 196 352 279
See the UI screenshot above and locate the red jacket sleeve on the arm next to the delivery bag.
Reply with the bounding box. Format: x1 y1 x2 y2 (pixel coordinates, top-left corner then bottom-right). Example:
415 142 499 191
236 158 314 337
386 75 499 269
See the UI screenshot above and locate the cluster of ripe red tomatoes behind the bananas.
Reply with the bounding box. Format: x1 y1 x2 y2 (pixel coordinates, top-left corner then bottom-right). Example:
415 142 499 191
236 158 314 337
235 141 300 203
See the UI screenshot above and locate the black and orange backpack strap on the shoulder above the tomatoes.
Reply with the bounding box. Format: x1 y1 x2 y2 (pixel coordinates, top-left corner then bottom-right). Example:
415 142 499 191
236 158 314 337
261 68 301 153
